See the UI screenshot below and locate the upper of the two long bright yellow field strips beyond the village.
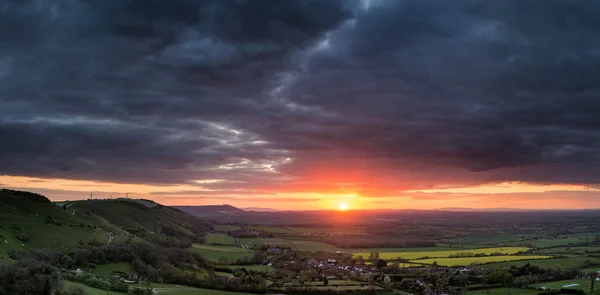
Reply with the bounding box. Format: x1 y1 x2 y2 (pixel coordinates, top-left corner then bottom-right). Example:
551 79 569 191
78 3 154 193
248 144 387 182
352 247 529 261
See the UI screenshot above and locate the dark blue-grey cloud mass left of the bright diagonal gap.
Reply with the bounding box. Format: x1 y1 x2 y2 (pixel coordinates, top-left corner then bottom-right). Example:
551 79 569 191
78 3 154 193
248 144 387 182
0 0 349 183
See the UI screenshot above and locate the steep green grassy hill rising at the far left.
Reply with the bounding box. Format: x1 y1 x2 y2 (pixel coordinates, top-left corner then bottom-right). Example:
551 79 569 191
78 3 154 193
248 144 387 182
0 189 212 260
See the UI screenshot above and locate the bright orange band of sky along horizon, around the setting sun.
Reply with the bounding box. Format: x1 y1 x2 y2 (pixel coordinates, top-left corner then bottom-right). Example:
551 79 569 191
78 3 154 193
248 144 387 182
0 175 600 212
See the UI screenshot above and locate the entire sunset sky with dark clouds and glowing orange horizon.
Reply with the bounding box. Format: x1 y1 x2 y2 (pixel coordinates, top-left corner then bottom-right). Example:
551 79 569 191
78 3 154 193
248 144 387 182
0 0 600 210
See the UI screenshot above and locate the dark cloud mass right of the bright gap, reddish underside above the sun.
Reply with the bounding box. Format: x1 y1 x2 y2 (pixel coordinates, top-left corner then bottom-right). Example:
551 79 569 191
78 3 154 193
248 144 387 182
262 1 600 187
